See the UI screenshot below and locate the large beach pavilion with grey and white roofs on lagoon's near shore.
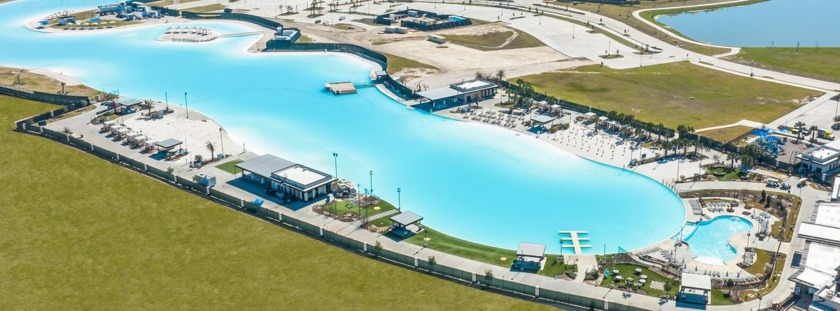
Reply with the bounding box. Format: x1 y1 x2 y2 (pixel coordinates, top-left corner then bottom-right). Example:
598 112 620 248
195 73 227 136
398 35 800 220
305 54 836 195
236 154 336 201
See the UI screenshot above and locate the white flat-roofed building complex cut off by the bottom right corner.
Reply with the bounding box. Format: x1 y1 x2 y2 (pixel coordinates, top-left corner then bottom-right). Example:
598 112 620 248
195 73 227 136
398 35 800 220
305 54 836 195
790 202 840 310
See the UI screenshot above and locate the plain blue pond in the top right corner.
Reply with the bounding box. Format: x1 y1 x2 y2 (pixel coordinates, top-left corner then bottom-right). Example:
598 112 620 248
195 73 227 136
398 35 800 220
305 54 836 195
657 0 840 47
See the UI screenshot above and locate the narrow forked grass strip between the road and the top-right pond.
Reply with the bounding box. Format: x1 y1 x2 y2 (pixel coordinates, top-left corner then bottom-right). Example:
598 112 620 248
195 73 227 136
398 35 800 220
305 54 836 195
560 0 762 55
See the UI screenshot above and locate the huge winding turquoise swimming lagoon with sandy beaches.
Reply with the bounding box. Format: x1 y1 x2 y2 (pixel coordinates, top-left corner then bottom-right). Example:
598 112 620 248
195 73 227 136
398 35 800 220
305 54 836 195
0 0 685 253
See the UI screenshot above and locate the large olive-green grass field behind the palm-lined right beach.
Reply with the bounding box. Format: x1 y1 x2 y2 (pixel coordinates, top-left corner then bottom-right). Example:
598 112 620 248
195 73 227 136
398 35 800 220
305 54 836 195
522 62 820 129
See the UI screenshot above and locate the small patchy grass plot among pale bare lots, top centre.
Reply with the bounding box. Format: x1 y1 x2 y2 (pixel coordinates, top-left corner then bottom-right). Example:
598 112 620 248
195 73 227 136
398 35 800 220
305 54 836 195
445 30 545 51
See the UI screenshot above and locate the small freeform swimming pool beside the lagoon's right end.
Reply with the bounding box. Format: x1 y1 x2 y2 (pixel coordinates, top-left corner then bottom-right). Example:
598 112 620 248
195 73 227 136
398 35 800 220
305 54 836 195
684 216 752 262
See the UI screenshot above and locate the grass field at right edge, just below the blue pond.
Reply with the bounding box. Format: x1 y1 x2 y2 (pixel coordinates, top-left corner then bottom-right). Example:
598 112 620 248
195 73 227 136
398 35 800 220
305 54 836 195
728 47 840 82
